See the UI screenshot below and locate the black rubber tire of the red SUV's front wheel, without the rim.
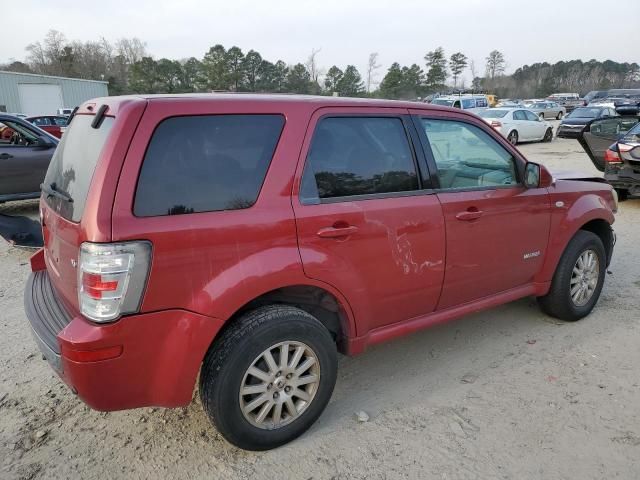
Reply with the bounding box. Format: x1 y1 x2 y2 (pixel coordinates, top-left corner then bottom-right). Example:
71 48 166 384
538 230 607 322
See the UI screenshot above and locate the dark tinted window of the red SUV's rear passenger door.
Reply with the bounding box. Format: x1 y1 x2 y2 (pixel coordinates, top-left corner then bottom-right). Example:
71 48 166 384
300 117 418 203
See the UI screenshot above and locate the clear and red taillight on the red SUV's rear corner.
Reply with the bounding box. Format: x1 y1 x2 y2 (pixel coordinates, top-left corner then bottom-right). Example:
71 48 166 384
78 242 151 322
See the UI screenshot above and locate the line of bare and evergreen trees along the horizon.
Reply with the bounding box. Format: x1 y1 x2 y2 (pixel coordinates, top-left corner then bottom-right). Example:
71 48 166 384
0 30 640 99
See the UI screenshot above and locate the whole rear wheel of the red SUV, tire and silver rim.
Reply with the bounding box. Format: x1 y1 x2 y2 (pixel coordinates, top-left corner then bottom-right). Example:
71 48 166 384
200 305 337 450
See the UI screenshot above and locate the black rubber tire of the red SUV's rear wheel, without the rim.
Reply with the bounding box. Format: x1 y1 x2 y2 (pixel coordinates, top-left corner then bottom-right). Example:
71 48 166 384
200 305 337 450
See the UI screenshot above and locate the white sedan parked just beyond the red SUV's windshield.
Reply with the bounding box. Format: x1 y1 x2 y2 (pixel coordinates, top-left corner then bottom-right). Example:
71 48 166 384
478 108 553 145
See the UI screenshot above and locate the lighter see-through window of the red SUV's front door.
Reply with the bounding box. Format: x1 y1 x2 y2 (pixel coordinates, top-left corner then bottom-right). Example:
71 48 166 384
422 119 518 190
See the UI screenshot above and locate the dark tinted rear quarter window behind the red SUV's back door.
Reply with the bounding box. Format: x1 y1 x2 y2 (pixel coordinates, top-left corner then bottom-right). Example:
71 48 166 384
134 115 284 217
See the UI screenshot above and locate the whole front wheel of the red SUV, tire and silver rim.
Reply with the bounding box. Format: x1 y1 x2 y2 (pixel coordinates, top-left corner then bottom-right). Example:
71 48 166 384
538 230 607 321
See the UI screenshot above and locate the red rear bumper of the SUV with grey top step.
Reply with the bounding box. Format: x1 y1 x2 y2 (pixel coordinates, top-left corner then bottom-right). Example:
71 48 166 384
25 270 222 411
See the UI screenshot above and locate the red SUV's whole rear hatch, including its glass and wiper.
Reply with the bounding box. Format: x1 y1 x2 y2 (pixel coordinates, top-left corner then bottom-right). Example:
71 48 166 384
40 99 146 314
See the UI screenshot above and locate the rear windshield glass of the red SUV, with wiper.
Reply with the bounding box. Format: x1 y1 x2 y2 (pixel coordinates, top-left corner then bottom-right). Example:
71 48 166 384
44 115 114 222
